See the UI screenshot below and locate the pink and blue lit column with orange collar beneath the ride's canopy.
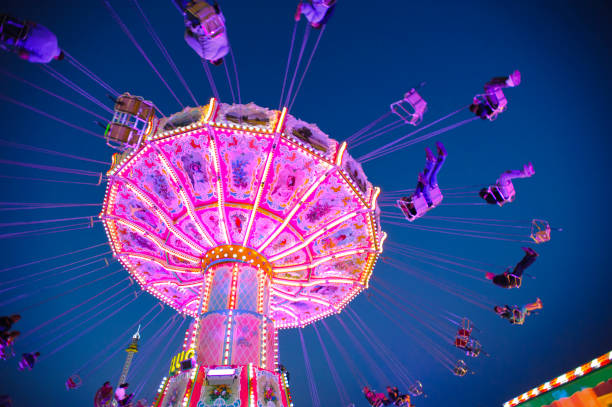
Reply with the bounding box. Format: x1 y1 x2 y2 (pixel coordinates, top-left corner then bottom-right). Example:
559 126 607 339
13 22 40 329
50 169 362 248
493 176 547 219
193 245 276 370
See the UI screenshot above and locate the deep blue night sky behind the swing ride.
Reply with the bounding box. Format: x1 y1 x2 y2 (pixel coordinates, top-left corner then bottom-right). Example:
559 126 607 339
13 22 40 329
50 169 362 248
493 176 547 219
0 0 612 407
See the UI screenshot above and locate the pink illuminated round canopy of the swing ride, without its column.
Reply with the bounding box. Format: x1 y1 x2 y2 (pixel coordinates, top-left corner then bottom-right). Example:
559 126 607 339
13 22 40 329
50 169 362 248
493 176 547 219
101 99 385 328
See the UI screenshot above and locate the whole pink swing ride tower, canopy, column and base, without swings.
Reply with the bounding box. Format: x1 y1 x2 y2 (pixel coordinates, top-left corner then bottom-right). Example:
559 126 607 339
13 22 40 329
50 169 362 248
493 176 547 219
100 98 386 407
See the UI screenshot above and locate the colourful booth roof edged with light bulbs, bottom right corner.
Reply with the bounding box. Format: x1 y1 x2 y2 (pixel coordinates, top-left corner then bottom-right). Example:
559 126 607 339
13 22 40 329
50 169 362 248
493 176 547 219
503 351 612 407
